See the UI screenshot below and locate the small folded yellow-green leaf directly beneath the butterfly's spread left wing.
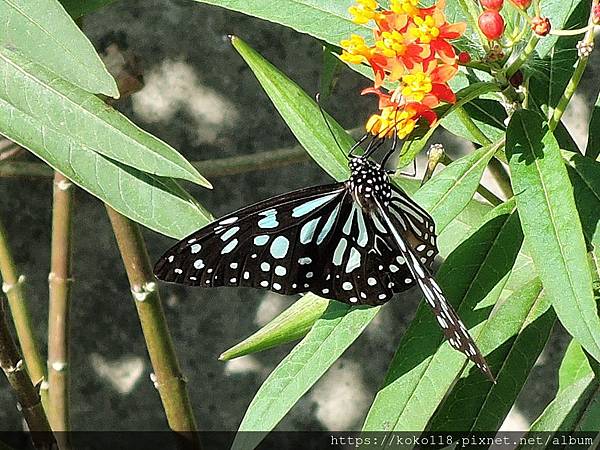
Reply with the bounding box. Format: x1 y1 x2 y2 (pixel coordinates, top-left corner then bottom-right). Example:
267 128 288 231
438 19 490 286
219 294 329 361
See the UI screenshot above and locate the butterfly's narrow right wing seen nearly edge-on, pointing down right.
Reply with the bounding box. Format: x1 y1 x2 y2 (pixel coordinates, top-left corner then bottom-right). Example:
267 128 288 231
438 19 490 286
378 195 495 382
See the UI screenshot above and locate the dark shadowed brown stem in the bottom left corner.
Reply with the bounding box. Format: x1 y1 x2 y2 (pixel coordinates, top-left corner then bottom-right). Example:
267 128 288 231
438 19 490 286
0 298 56 449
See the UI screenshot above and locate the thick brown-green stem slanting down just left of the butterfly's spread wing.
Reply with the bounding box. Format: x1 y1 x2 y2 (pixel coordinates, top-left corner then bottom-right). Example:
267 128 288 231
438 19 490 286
106 205 200 448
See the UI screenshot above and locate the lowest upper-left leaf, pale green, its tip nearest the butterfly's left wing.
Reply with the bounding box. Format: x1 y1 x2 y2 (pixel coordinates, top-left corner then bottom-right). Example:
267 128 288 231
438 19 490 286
0 94 211 238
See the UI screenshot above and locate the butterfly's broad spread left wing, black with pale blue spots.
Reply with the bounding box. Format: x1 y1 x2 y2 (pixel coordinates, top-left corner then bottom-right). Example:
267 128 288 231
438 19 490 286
154 183 414 305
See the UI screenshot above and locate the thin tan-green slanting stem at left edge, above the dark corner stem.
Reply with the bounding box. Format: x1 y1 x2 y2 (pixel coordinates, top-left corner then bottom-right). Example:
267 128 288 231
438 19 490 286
0 214 48 404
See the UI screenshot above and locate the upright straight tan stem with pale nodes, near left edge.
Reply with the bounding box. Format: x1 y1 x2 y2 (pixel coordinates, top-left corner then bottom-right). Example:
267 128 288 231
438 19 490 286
48 172 73 431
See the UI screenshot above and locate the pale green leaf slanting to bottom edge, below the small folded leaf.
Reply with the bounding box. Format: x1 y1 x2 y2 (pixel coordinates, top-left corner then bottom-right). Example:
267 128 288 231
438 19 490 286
232 302 380 450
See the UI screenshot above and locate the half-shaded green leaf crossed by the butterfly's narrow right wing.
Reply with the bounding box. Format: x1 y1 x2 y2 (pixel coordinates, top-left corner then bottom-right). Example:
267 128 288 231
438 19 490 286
363 202 522 431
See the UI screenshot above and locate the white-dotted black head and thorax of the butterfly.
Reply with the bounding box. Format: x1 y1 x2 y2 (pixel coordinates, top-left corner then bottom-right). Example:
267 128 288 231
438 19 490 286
347 157 392 211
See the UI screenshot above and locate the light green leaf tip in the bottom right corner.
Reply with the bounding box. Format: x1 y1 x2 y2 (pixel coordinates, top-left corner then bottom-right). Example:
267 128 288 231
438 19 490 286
517 371 600 450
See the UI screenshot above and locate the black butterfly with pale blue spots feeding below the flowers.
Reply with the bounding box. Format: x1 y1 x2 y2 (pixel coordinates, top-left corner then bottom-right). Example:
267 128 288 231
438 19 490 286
154 134 495 382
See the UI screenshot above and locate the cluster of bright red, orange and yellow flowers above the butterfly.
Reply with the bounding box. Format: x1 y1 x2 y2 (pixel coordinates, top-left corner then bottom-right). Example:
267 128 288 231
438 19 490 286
341 0 466 139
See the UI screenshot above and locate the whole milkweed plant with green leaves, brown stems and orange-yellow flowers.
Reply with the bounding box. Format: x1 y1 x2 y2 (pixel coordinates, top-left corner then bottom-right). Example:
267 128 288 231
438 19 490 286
0 0 600 449
